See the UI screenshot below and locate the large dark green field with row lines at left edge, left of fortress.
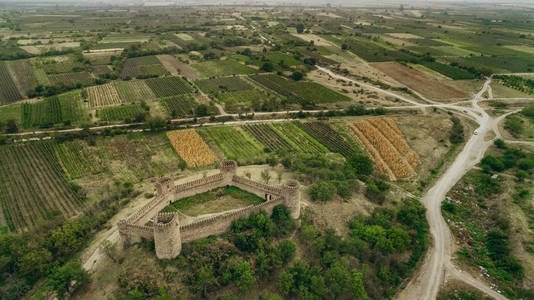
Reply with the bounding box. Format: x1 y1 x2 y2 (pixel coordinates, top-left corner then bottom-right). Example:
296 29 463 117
0 142 84 231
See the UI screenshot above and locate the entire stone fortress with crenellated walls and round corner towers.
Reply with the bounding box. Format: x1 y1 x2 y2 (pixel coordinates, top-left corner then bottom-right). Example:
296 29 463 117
118 160 300 259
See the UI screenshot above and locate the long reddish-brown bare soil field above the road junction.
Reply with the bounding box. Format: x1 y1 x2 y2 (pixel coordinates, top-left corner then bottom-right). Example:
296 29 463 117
371 62 469 101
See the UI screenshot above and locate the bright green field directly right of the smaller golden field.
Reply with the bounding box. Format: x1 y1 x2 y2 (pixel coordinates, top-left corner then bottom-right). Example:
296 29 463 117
198 127 264 164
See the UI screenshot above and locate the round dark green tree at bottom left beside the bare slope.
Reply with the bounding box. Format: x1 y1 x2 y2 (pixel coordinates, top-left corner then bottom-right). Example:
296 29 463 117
47 261 91 299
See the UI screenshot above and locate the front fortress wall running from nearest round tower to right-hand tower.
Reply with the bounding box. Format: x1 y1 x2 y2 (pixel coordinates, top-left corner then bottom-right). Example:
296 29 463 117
180 198 284 243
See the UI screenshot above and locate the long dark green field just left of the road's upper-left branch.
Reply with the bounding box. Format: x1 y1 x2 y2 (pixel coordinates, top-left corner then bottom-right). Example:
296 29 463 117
250 75 349 106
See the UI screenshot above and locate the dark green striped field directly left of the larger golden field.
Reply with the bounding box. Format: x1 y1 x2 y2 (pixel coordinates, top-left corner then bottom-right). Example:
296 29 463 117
295 122 356 158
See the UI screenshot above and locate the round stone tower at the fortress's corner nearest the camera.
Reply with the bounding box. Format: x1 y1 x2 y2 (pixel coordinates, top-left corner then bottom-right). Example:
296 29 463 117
154 213 182 259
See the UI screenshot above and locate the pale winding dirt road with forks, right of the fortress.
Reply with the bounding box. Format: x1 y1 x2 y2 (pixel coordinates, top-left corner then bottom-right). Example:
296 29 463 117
318 67 517 300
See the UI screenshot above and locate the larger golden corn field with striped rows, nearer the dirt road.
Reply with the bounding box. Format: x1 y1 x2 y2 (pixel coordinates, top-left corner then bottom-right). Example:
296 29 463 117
351 118 420 179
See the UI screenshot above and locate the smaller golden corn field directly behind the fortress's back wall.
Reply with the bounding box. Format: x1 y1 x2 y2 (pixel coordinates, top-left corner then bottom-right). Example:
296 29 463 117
167 129 216 167
